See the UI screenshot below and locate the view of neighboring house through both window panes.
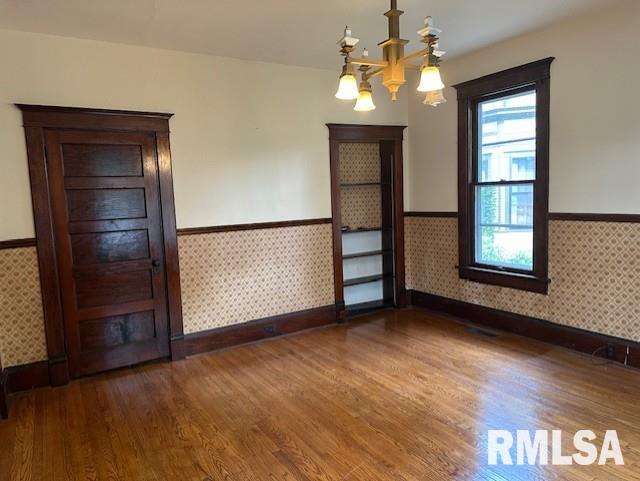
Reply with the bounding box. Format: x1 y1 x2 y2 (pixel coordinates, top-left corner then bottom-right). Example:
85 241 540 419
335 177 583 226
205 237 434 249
474 89 536 271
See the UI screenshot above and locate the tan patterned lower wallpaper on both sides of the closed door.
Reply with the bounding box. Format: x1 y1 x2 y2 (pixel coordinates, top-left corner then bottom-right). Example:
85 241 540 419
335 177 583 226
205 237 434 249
0 223 335 368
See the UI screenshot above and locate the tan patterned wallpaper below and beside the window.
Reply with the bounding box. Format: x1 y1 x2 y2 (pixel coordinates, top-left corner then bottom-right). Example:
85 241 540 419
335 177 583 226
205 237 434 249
405 217 640 341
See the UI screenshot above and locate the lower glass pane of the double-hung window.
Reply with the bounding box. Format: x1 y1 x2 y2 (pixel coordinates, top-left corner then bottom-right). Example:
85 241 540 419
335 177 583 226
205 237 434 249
475 184 533 271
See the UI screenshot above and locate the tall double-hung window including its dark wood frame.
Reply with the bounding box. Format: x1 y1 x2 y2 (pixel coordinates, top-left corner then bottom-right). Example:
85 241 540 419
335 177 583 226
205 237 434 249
456 58 553 293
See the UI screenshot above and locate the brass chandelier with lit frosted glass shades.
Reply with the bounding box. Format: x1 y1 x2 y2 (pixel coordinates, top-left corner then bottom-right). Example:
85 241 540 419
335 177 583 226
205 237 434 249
336 0 446 112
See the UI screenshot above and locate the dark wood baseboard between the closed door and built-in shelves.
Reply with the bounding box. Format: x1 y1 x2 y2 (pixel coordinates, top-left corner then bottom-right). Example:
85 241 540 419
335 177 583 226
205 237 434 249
184 305 337 356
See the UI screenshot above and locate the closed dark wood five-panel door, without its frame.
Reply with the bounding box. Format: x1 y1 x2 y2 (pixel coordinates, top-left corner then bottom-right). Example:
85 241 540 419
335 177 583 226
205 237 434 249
45 130 169 377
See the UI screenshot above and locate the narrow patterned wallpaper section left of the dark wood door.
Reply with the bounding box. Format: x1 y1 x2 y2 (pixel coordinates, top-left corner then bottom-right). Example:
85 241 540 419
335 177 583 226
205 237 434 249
0 247 47 368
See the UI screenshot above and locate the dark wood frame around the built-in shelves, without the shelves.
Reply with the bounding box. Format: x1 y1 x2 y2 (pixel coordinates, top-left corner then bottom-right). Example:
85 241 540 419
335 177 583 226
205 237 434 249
326 124 407 320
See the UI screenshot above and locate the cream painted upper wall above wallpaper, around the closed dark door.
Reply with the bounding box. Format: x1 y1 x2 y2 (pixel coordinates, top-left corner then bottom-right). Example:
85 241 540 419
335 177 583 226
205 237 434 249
0 30 408 240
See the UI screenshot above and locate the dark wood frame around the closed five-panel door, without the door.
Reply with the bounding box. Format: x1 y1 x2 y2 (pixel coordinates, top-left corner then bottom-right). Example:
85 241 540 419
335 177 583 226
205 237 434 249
16 104 185 386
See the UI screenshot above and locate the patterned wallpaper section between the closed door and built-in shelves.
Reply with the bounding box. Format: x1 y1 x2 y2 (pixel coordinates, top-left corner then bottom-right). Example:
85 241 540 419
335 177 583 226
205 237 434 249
178 224 335 334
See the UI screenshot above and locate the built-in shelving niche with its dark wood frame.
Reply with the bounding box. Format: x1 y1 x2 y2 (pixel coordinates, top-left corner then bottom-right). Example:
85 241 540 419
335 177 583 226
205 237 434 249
327 124 406 320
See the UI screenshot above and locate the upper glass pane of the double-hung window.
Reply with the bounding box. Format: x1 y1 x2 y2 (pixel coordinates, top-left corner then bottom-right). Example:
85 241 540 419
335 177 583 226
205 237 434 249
478 91 536 182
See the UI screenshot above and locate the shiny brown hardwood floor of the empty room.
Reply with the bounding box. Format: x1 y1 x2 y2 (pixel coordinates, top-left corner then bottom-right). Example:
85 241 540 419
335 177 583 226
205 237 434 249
0 309 640 481
